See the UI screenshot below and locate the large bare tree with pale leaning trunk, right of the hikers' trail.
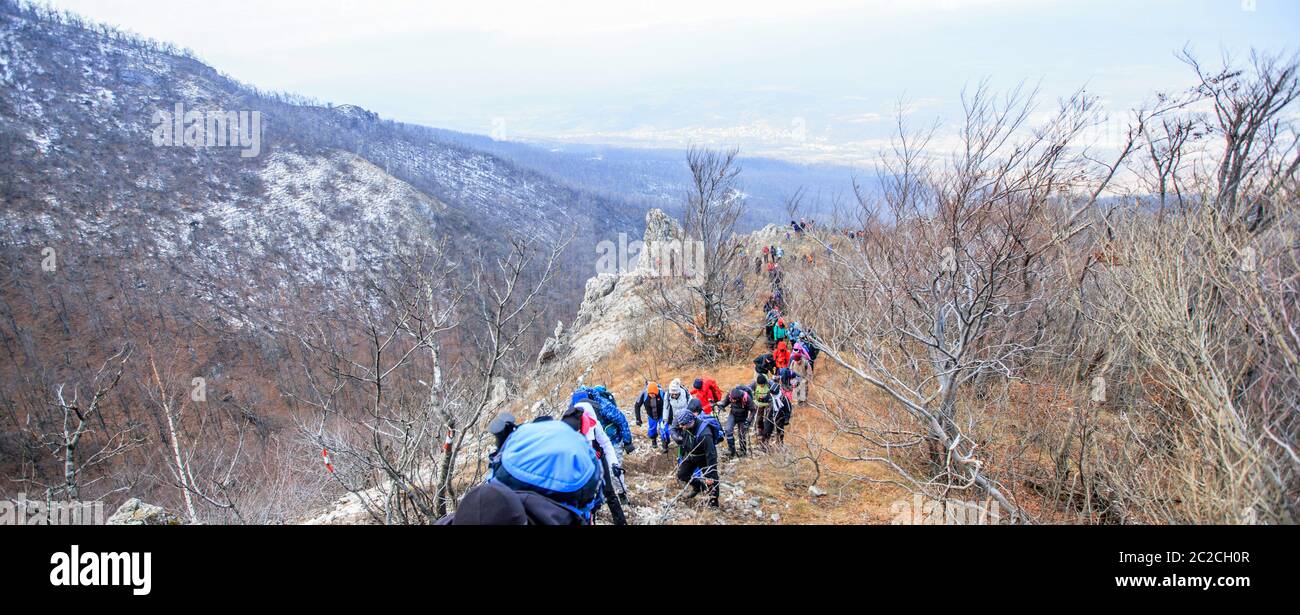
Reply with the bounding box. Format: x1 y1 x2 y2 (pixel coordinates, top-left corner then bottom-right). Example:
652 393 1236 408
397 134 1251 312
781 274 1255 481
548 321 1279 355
805 87 1133 519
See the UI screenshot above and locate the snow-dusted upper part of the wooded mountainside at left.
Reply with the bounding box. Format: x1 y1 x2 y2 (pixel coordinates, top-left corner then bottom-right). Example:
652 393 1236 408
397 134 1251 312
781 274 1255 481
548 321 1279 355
0 0 640 326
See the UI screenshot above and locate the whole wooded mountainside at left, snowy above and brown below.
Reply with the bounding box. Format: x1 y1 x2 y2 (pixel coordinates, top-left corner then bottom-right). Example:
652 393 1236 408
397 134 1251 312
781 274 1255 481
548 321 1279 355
0 1 644 514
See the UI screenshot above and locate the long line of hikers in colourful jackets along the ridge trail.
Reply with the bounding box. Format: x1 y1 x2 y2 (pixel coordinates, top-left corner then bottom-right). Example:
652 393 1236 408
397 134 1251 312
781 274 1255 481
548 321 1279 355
438 241 820 525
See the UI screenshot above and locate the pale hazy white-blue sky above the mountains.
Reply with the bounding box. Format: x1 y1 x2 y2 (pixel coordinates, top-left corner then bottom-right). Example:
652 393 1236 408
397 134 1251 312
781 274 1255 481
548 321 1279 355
45 0 1300 161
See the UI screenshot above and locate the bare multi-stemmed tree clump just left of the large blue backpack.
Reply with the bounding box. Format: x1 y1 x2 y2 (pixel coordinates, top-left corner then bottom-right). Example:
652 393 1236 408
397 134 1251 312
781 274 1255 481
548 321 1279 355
287 238 568 523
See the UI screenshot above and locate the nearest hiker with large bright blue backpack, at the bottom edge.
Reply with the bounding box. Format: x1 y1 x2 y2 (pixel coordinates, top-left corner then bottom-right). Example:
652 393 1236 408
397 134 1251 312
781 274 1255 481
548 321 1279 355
436 421 603 525
